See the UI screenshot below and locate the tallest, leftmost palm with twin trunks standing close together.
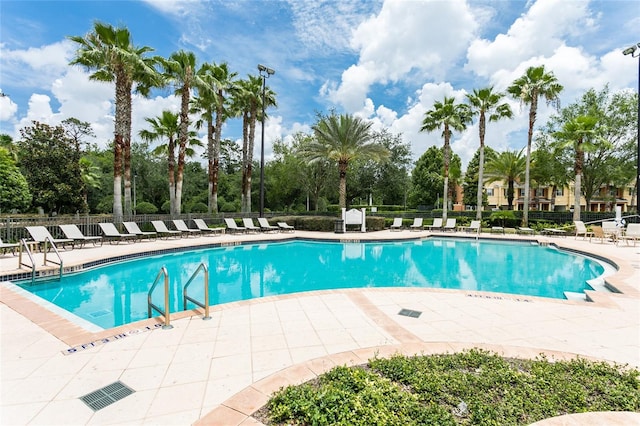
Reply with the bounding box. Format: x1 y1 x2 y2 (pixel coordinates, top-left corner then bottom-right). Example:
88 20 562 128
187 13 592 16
69 22 158 221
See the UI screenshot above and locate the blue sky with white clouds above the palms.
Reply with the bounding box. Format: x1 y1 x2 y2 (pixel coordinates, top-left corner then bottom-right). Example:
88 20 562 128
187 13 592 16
0 0 640 170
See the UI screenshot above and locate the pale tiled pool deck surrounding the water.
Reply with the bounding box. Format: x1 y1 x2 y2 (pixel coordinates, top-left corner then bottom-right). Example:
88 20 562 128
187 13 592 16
0 230 640 426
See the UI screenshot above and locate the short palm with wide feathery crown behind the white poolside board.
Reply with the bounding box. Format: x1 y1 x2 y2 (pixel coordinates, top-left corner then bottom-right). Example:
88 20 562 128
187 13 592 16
300 113 389 208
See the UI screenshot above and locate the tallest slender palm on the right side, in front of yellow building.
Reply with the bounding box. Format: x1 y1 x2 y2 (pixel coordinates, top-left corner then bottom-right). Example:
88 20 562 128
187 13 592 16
507 65 563 226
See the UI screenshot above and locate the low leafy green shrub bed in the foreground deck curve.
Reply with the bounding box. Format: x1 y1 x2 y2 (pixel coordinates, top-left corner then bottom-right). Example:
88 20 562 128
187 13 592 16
254 349 640 426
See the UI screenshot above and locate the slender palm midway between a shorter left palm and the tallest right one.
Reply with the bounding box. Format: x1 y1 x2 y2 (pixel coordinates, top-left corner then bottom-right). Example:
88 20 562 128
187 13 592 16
467 86 513 219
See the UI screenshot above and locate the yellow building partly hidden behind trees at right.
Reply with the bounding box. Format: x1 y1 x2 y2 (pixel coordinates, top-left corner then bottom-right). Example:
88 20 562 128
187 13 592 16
484 182 636 212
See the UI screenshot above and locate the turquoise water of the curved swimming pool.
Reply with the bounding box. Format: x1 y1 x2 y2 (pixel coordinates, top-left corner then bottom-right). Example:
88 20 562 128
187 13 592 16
13 238 604 328
